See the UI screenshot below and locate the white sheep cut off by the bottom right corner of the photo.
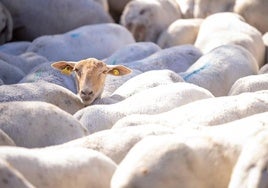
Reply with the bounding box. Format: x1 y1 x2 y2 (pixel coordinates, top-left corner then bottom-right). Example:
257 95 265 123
229 129 268 188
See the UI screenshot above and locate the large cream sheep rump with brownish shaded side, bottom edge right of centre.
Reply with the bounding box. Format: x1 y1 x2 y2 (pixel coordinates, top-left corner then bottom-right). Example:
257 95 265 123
111 134 237 188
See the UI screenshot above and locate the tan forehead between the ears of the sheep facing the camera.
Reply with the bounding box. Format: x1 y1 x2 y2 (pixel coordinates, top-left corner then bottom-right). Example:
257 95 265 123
75 58 106 73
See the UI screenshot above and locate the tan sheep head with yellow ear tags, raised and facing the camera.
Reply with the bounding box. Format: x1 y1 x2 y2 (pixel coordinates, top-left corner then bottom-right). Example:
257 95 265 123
51 58 131 105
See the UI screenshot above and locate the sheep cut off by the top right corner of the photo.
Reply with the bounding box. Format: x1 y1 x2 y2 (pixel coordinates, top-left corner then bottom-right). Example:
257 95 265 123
234 0 268 33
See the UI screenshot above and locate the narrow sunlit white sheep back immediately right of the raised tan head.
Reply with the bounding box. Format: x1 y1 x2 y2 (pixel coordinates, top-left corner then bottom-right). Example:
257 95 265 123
110 69 184 100
